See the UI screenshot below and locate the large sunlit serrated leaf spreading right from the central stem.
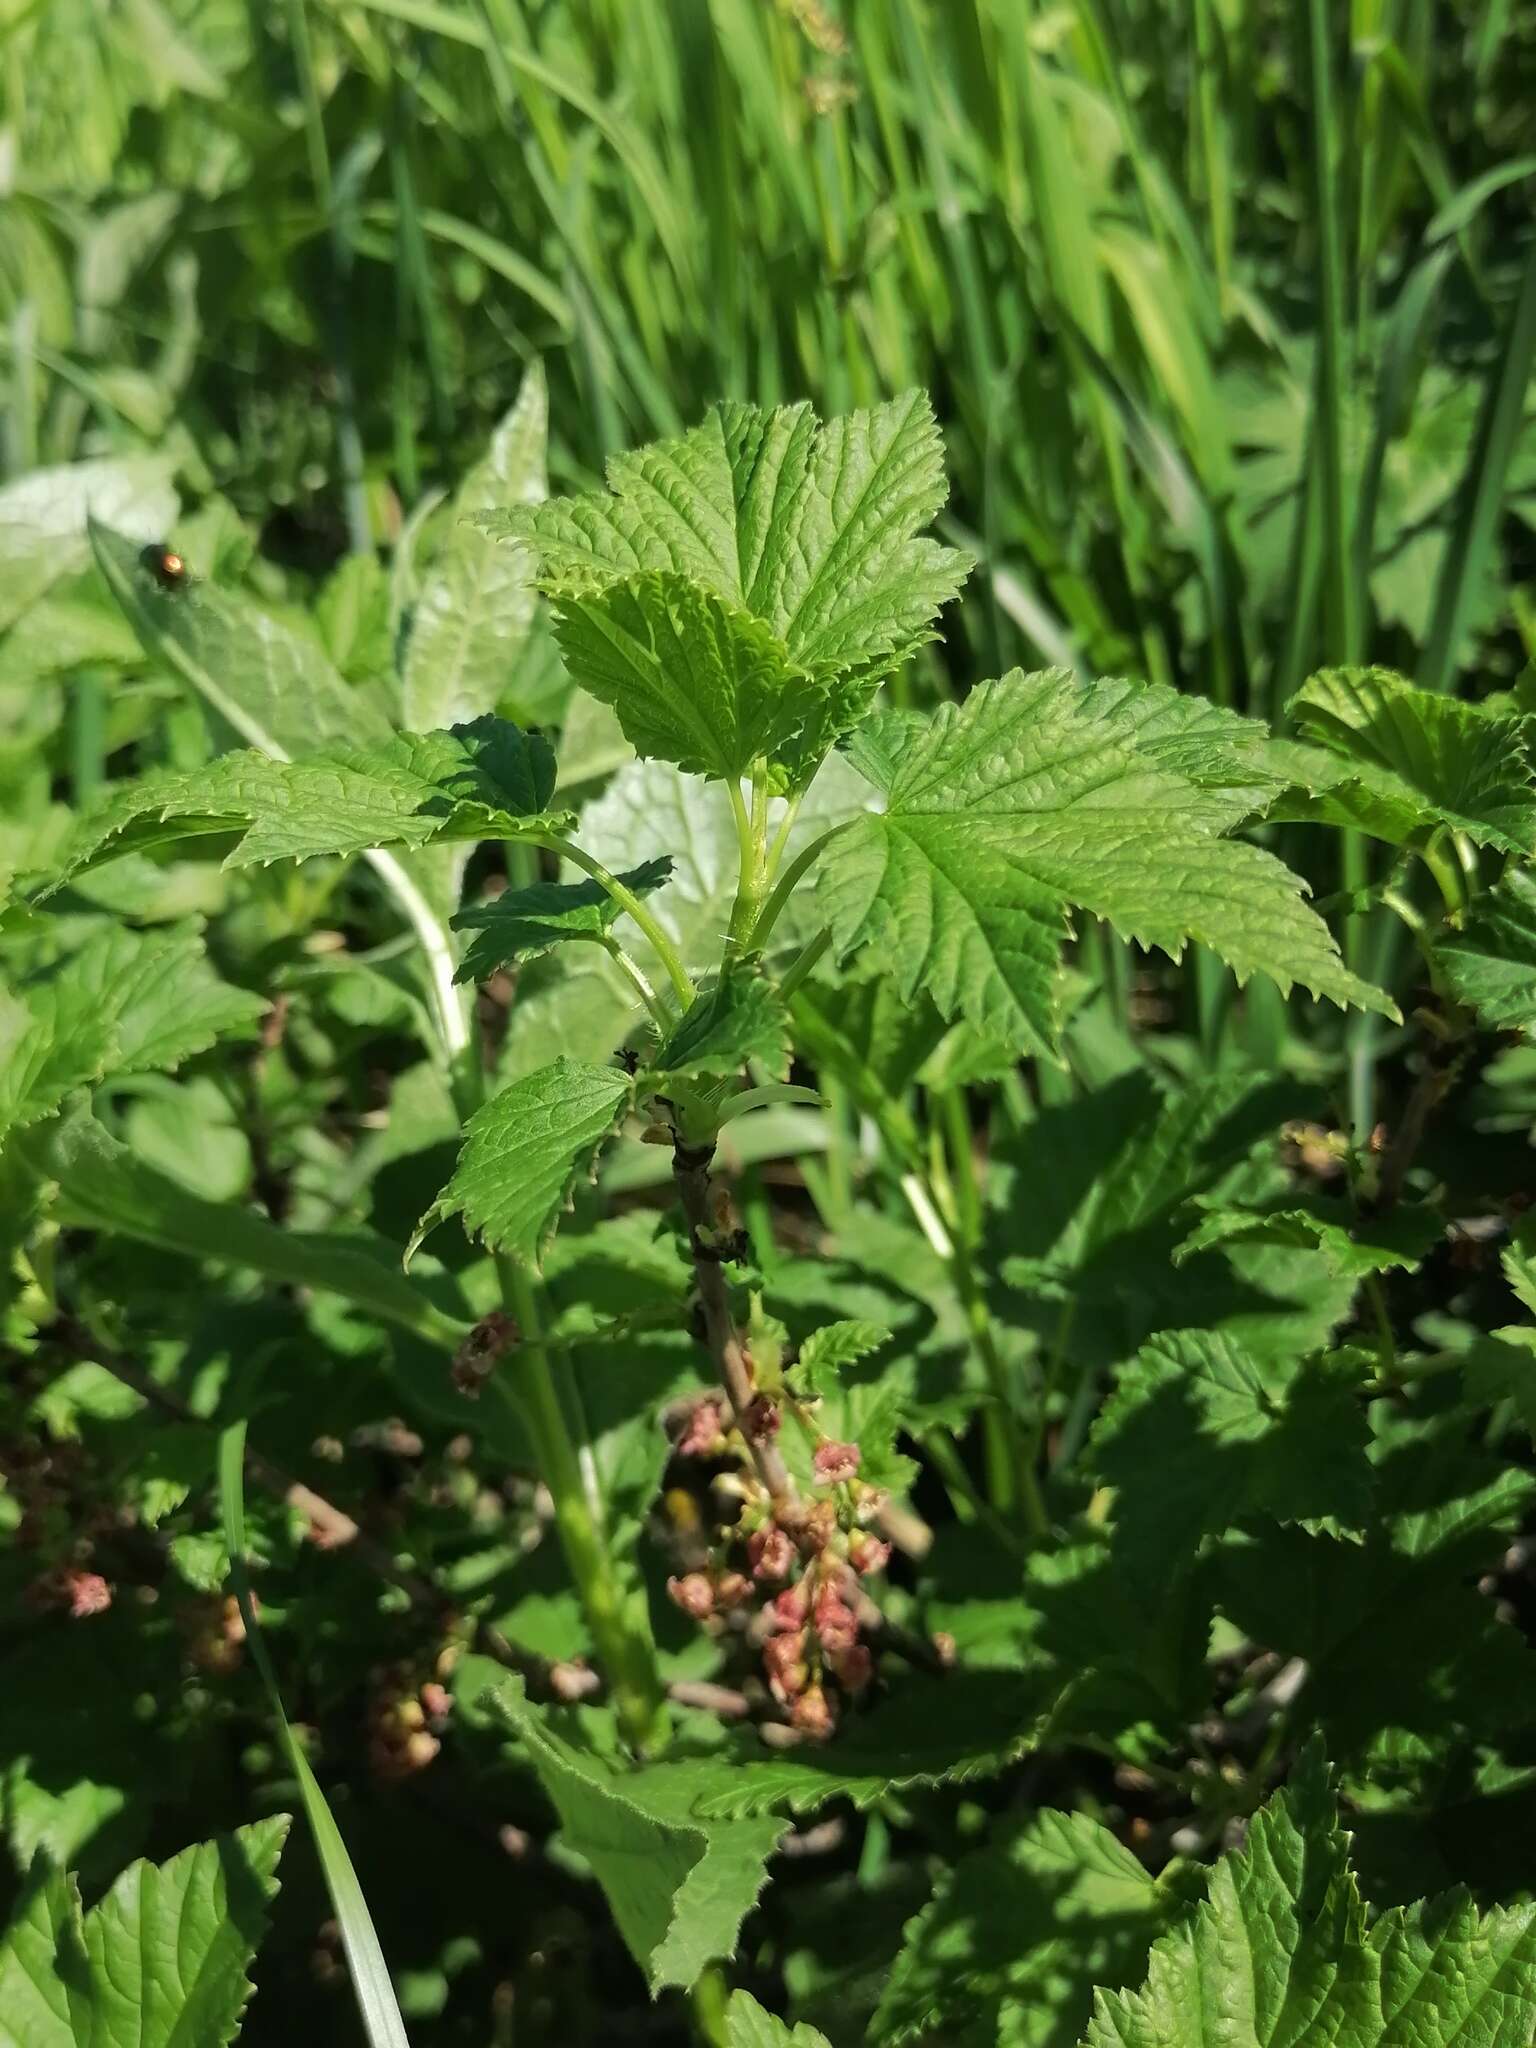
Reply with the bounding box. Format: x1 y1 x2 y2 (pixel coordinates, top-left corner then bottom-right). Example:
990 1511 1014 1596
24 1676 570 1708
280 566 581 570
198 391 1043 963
819 670 1395 1051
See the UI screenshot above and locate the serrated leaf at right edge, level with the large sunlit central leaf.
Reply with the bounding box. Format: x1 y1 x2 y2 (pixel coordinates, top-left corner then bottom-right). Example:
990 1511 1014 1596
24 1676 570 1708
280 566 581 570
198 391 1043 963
1276 668 1536 852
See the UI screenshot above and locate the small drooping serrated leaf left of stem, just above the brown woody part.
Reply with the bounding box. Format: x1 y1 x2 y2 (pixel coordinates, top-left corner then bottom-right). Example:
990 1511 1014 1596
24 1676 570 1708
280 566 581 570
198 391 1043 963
416 1059 631 1266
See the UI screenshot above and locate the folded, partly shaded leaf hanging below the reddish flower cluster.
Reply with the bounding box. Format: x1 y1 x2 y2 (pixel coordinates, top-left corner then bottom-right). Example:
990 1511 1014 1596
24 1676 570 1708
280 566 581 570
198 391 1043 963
485 1677 784 1993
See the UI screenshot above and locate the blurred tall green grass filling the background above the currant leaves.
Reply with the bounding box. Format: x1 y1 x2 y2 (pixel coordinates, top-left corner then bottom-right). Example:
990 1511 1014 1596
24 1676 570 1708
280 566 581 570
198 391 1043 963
0 0 1536 713
